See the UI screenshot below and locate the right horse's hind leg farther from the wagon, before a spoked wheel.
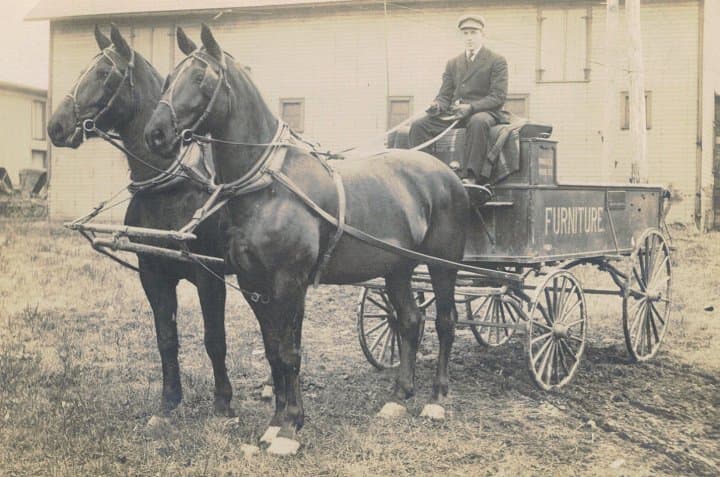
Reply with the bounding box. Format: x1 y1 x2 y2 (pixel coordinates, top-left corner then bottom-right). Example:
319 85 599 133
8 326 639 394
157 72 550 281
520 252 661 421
383 267 422 412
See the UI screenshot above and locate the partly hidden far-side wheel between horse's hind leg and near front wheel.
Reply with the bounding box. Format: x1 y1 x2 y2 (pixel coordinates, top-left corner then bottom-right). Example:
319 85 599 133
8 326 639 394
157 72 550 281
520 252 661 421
465 292 522 348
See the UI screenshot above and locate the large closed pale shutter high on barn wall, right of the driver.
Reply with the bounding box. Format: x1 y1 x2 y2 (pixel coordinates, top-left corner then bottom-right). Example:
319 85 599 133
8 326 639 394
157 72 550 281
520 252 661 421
536 7 592 81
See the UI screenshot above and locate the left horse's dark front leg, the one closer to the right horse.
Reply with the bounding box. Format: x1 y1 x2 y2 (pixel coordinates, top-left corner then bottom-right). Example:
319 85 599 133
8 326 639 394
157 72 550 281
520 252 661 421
196 272 234 417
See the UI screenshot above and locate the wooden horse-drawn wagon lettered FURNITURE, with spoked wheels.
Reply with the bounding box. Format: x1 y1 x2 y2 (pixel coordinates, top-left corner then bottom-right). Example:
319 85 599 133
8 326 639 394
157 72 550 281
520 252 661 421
357 124 672 390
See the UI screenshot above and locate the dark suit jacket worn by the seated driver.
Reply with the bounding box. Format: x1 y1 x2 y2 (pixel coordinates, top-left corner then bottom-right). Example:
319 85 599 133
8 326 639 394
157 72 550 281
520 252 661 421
435 46 508 123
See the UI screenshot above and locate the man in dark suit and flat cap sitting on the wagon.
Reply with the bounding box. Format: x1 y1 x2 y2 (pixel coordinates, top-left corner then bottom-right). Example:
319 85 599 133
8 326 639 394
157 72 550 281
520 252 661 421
409 15 509 184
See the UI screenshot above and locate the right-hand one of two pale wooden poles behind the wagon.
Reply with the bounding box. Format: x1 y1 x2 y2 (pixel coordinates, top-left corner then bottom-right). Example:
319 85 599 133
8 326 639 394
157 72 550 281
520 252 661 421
625 0 648 183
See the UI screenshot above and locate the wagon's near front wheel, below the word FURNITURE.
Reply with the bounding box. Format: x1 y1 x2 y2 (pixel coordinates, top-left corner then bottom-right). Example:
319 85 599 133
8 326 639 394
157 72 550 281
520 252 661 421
526 270 587 391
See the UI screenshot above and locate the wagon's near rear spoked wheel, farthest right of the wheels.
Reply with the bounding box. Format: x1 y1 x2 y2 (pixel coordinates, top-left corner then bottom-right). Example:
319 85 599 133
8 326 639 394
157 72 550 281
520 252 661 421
623 229 672 361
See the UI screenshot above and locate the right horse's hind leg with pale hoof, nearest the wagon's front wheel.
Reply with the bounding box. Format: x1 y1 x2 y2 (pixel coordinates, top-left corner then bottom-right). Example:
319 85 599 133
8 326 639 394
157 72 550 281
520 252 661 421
421 267 457 419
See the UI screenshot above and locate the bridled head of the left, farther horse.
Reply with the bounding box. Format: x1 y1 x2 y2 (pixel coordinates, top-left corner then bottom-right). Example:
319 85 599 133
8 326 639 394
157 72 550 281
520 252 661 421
47 25 136 148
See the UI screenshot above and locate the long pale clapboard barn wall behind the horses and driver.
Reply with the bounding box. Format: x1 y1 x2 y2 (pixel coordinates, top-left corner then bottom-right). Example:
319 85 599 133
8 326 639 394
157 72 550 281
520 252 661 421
51 1 699 222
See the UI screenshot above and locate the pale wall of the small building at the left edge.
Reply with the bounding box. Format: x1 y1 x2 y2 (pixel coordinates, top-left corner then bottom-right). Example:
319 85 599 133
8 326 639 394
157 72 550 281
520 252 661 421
0 88 47 188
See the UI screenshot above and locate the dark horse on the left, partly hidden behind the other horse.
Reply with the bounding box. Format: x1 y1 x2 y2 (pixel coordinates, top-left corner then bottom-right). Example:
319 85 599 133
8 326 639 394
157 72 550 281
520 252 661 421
47 25 239 416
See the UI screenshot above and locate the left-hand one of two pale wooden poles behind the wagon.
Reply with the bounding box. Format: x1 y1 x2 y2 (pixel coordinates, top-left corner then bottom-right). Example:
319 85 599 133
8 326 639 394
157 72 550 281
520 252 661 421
601 0 620 182
